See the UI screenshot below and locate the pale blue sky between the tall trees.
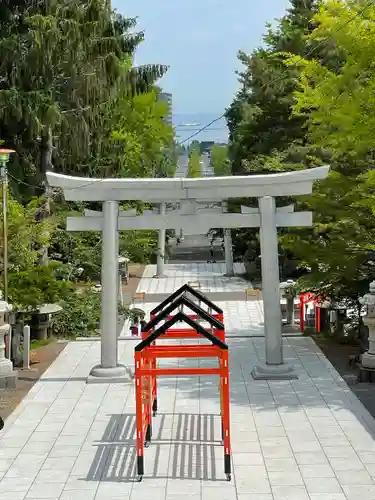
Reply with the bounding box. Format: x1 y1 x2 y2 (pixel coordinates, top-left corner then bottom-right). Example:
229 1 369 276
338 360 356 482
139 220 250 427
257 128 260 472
113 0 289 114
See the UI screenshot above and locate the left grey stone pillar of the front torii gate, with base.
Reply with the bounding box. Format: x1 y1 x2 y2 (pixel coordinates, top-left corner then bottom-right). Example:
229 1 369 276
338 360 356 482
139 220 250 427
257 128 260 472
88 201 130 383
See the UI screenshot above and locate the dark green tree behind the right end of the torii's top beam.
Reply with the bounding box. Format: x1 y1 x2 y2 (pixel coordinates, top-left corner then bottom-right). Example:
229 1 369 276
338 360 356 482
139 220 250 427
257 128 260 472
227 0 324 174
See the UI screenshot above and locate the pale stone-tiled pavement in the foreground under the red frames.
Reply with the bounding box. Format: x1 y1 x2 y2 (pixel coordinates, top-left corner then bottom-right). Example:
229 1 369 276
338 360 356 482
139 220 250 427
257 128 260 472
0 337 375 500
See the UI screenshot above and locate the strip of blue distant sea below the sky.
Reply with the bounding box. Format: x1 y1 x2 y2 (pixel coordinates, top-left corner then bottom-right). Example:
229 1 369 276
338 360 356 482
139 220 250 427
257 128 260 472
173 112 228 143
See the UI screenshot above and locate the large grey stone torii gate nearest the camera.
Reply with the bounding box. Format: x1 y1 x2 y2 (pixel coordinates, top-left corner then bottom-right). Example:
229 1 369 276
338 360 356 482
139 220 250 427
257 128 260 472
47 166 329 382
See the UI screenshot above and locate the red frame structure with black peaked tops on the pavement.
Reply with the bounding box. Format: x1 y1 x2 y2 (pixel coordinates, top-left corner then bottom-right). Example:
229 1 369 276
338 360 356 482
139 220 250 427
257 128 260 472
135 285 231 481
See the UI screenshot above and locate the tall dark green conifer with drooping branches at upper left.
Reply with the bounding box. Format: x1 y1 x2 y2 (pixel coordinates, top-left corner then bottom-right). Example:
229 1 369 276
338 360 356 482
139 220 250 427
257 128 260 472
0 0 165 193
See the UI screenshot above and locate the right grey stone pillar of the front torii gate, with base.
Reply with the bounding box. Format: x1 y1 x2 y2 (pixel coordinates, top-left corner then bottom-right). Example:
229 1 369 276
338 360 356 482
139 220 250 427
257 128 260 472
252 196 298 380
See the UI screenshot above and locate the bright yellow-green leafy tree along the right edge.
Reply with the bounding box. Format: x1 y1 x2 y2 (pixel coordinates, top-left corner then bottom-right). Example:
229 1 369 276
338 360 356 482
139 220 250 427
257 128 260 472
283 1 375 304
